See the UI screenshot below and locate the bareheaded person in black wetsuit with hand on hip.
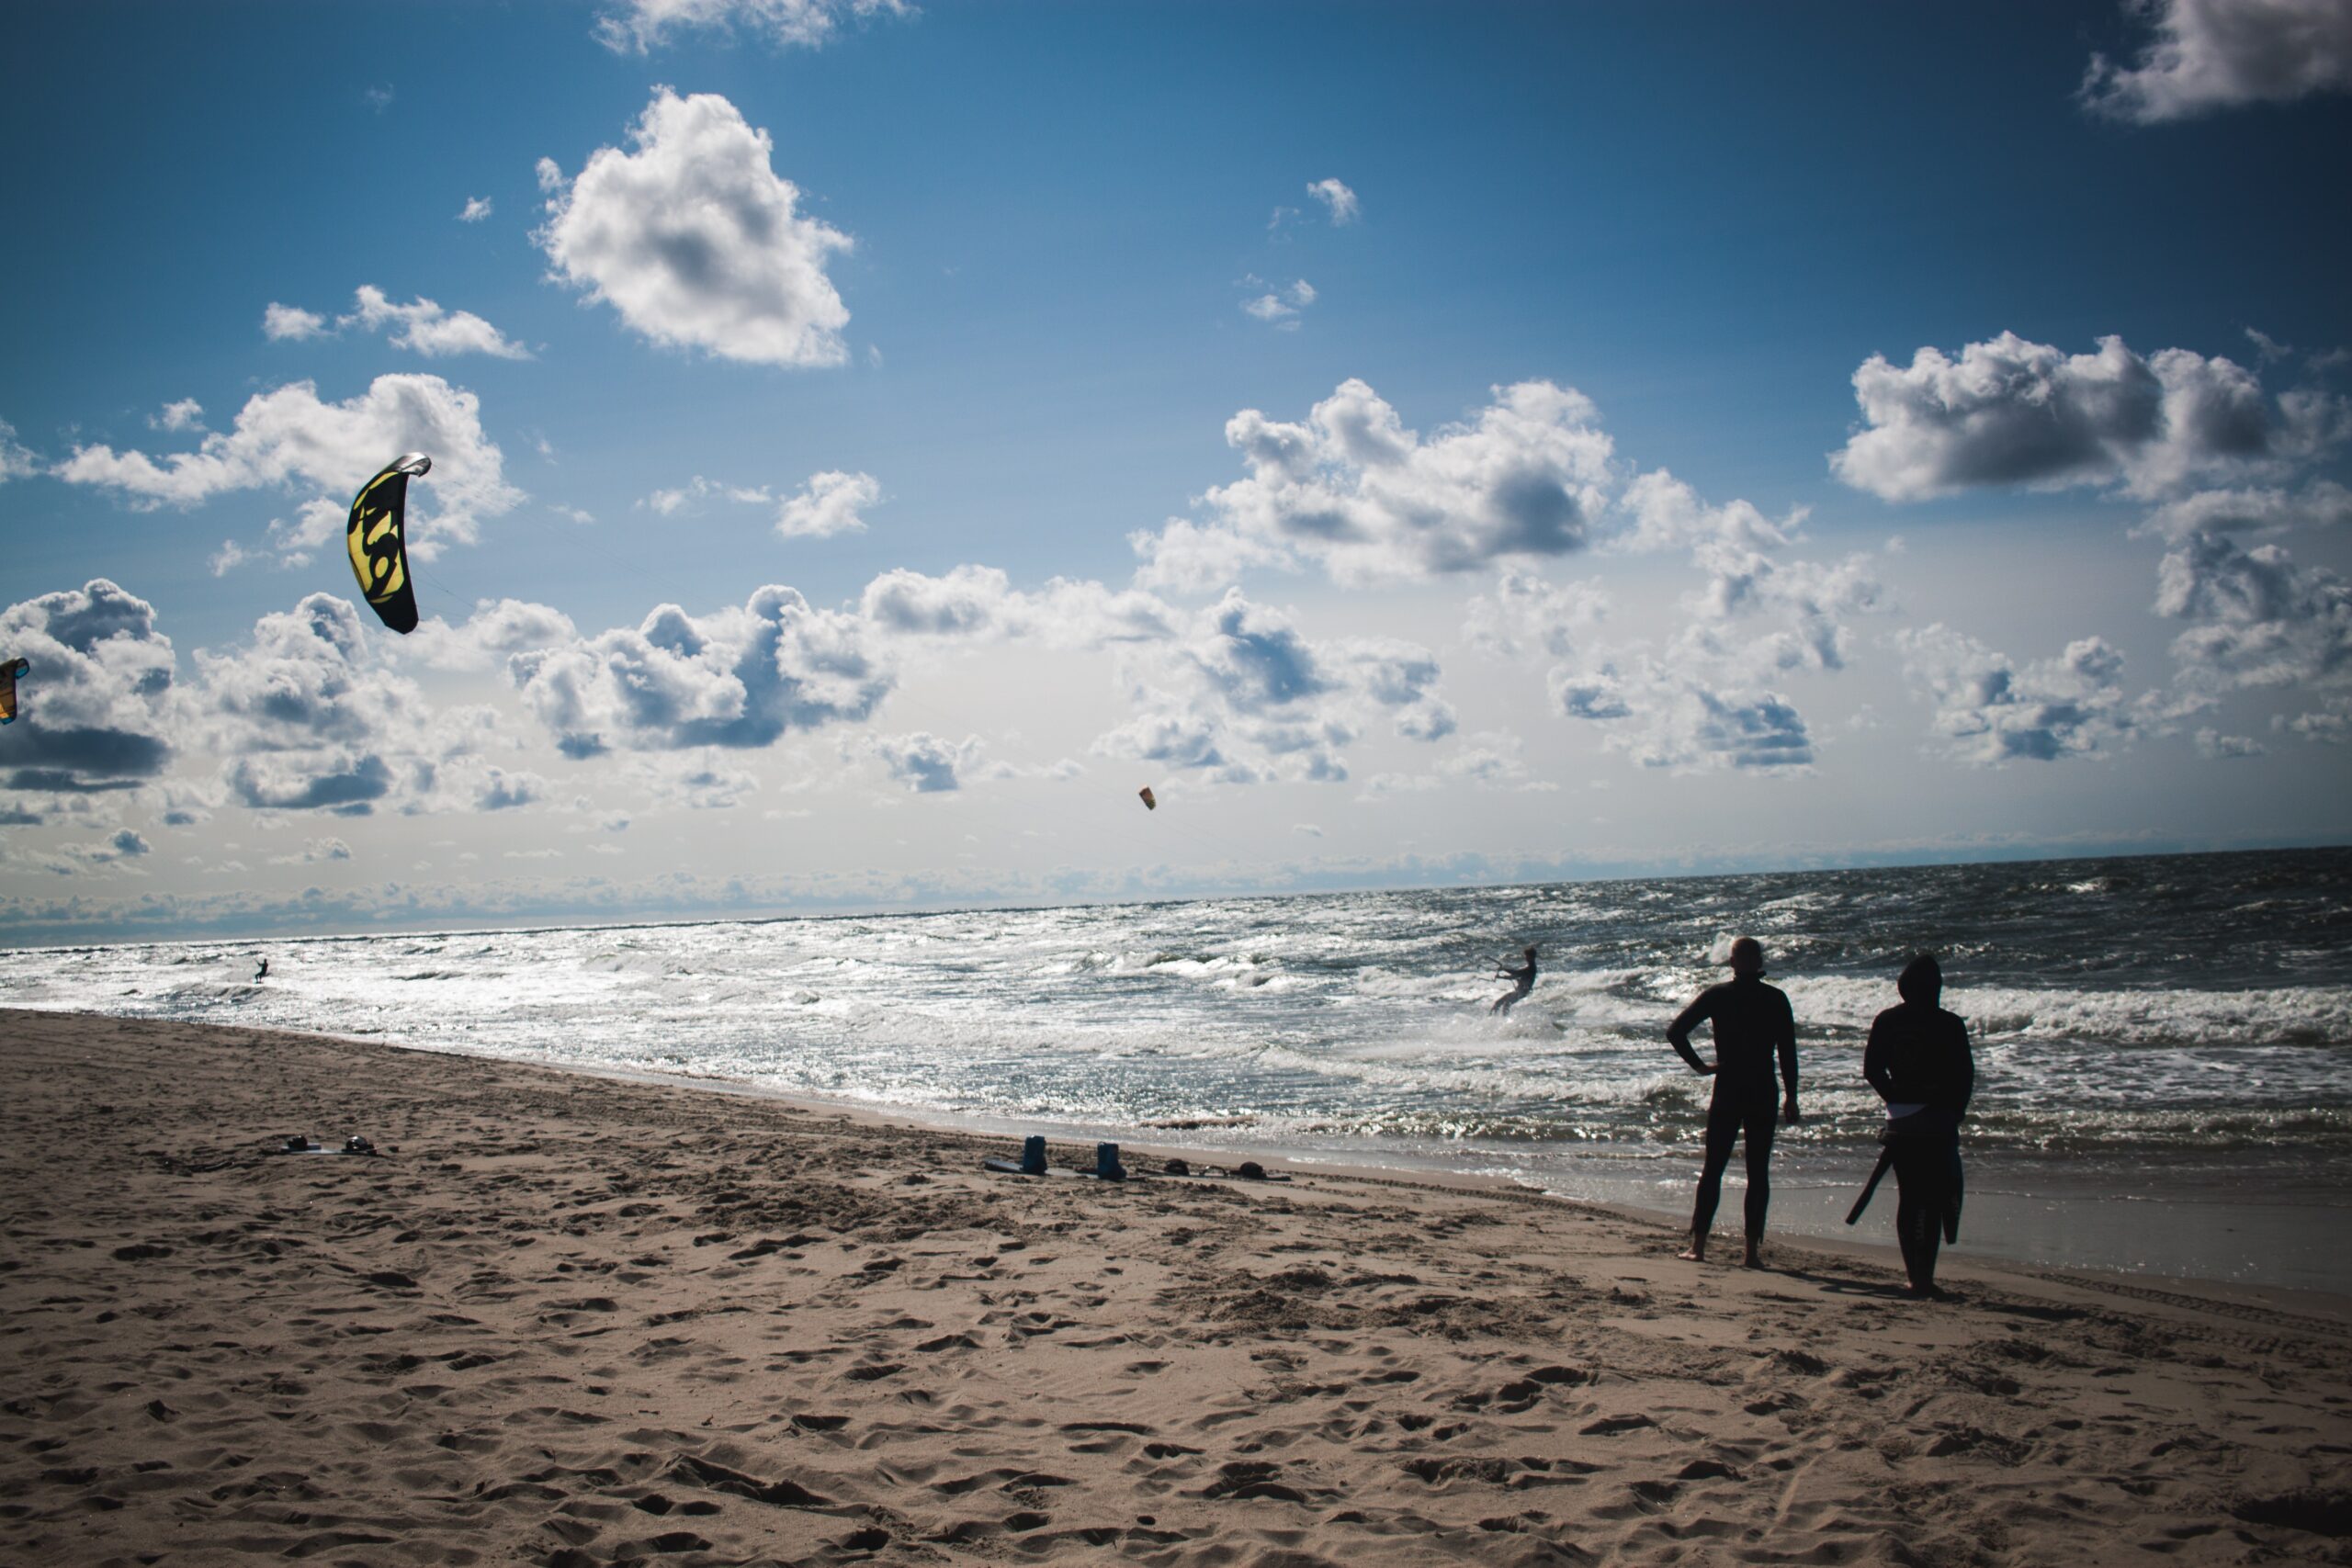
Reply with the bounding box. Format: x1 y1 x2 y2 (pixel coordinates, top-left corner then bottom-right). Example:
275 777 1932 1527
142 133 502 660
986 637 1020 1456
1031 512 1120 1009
1665 936 1799 1269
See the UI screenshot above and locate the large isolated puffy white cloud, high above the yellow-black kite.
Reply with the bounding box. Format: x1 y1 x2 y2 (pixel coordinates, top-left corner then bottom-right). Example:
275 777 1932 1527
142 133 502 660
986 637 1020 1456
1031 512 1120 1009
534 87 852 367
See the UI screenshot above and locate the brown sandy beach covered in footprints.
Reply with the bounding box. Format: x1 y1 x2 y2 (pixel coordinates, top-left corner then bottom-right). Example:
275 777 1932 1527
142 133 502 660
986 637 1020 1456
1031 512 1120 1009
0 1013 2352 1568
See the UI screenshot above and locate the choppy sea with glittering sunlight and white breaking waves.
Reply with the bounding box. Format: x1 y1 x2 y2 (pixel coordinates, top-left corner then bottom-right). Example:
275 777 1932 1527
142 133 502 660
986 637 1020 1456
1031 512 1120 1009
0 849 2352 1293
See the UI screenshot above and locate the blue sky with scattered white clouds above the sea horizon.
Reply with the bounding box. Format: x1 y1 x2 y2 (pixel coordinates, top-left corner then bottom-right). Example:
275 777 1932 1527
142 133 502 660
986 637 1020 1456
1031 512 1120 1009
0 0 2352 942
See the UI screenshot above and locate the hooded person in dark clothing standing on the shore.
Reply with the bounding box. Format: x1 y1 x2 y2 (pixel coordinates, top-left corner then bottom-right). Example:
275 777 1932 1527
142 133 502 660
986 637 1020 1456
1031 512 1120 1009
1863 952 1975 1298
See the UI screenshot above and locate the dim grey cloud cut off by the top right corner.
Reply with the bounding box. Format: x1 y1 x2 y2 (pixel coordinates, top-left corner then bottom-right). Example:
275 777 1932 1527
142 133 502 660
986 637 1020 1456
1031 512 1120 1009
2079 0 2352 125
